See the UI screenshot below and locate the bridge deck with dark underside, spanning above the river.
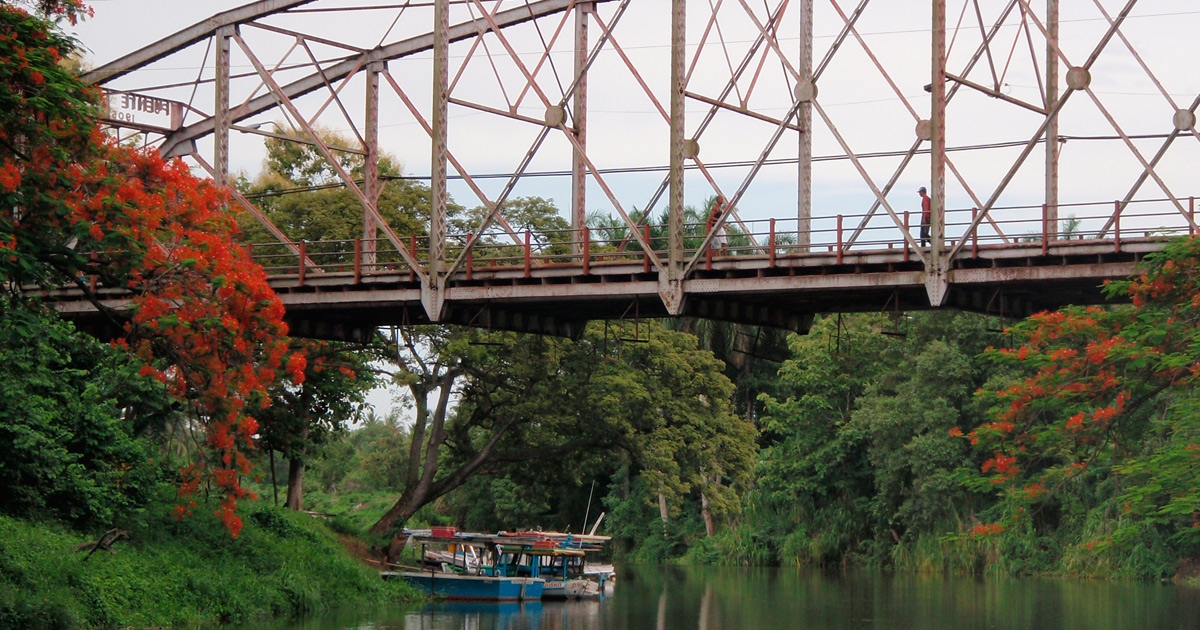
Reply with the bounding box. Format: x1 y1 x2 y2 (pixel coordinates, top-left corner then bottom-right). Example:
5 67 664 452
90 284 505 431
52 231 1166 338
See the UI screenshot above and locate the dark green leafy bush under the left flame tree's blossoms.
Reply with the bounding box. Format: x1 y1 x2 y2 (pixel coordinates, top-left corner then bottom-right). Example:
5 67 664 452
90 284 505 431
0 296 169 526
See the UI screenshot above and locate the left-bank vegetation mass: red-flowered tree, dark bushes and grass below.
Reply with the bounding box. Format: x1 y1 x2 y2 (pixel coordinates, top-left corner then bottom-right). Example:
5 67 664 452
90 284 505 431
0 0 410 628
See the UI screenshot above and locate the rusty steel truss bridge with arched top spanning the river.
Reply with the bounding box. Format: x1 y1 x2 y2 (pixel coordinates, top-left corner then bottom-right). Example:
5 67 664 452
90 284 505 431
60 0 1200 338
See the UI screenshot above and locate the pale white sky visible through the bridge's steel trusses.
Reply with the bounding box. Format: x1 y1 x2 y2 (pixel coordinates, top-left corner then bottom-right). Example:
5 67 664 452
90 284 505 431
76 0 1200 420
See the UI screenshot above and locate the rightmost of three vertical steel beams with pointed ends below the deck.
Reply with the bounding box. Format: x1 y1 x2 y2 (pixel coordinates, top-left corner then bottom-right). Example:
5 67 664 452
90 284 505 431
925 0 949 306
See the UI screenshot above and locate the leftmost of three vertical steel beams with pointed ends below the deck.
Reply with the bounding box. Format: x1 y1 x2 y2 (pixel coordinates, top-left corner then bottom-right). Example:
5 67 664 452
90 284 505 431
421 0 450 322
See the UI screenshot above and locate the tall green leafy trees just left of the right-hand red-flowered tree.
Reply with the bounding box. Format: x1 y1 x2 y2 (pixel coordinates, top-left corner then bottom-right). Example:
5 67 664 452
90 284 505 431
749 313 996 564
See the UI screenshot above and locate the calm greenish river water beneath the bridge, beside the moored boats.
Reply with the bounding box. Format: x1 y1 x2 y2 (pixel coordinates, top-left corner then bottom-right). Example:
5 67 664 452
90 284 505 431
267 566 1200 630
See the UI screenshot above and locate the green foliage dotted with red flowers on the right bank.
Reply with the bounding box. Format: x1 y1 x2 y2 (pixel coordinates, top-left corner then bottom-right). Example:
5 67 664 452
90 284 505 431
964 239 1200 580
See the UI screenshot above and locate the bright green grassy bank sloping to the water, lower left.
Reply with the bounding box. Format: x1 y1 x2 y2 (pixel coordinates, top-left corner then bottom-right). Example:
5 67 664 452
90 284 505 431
0 496 416 629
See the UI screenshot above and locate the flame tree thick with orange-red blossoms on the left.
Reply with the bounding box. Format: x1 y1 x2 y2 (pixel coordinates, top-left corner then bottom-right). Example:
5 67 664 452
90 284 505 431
0 1 298 535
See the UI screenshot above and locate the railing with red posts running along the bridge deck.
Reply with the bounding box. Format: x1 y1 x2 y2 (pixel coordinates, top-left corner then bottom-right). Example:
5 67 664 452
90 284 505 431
248 197 1195 278
